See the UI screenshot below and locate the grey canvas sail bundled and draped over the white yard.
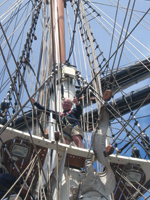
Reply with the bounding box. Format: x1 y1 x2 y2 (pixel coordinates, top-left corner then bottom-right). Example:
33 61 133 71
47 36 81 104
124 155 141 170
70 107 116 200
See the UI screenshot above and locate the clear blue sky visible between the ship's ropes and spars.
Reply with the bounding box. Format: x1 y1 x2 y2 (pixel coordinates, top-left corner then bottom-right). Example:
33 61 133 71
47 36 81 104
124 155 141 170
0 0 150 198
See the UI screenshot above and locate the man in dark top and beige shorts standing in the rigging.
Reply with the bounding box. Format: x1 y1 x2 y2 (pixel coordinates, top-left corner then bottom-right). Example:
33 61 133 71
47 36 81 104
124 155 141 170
31 97 84 148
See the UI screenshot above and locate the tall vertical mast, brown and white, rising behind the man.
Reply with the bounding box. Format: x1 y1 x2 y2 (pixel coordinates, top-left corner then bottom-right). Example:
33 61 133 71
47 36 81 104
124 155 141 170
49 0 79 200
